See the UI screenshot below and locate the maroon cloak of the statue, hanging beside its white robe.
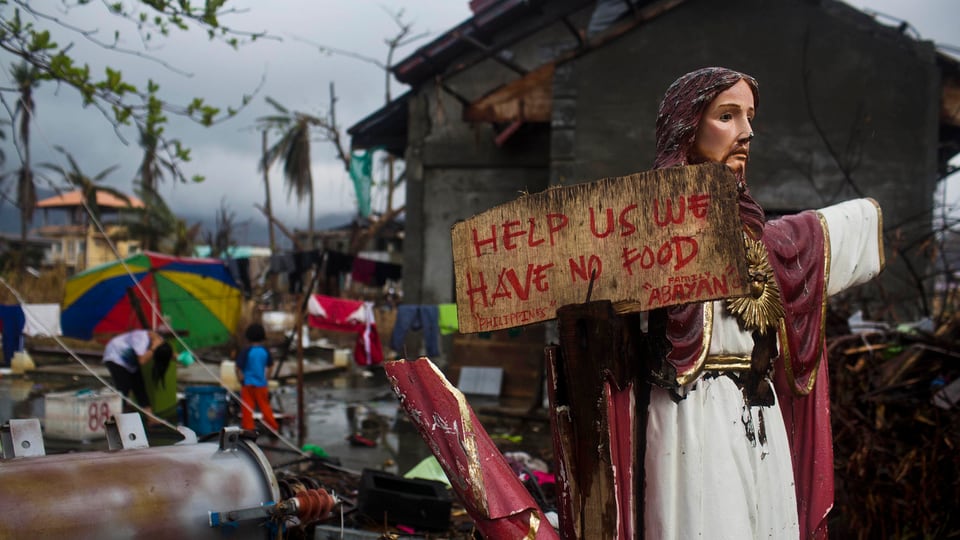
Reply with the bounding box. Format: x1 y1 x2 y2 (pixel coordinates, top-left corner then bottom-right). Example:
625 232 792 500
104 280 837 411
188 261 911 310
667 208 834 538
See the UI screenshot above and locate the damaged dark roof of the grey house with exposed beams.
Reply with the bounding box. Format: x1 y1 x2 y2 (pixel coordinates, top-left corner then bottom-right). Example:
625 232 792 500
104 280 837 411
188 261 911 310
347 0 960 167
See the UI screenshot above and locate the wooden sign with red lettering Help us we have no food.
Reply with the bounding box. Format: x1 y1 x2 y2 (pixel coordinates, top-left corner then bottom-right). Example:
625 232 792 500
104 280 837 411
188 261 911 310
452 164 747 333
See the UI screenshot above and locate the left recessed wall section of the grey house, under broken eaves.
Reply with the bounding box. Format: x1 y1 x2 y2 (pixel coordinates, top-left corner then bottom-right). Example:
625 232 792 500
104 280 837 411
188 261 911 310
403 84 549 304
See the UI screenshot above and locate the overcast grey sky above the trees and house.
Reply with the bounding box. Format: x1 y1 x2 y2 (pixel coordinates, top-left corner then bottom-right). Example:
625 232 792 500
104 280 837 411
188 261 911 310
0 0 960 245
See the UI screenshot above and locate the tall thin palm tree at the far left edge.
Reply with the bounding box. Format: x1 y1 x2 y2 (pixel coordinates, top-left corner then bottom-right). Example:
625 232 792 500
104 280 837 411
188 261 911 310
10 62 40 266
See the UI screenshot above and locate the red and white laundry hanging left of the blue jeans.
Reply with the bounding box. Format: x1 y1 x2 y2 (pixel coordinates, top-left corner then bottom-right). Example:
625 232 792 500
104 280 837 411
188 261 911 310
307 294 383 366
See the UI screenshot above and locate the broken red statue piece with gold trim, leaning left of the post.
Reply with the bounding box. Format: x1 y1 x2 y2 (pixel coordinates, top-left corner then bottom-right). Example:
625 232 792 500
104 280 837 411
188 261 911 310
384 358 559 540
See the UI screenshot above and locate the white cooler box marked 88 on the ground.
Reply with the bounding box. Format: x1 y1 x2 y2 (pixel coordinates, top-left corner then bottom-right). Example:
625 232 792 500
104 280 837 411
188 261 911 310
43 389 123 441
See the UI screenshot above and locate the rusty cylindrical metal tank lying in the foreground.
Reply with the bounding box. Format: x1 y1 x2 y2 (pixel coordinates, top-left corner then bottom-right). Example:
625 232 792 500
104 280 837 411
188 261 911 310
0 415 280 540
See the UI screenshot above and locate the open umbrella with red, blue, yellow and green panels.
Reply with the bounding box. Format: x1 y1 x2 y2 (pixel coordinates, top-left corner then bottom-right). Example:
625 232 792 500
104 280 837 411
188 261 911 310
60 252 241 349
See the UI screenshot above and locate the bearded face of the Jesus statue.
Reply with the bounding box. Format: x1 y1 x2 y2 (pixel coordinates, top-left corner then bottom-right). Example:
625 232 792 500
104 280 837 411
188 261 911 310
691 79 754 181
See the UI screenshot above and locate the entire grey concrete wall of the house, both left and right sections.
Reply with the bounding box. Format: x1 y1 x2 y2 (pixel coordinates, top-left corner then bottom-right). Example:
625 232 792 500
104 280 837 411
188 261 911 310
404 0 939 318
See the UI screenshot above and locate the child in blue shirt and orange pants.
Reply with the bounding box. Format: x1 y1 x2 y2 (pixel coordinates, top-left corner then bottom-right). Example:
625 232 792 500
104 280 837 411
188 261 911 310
237 323 280 431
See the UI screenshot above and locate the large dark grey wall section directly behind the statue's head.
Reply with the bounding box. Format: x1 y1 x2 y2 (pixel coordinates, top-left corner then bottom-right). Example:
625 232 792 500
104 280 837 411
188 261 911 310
564 0 939 315
